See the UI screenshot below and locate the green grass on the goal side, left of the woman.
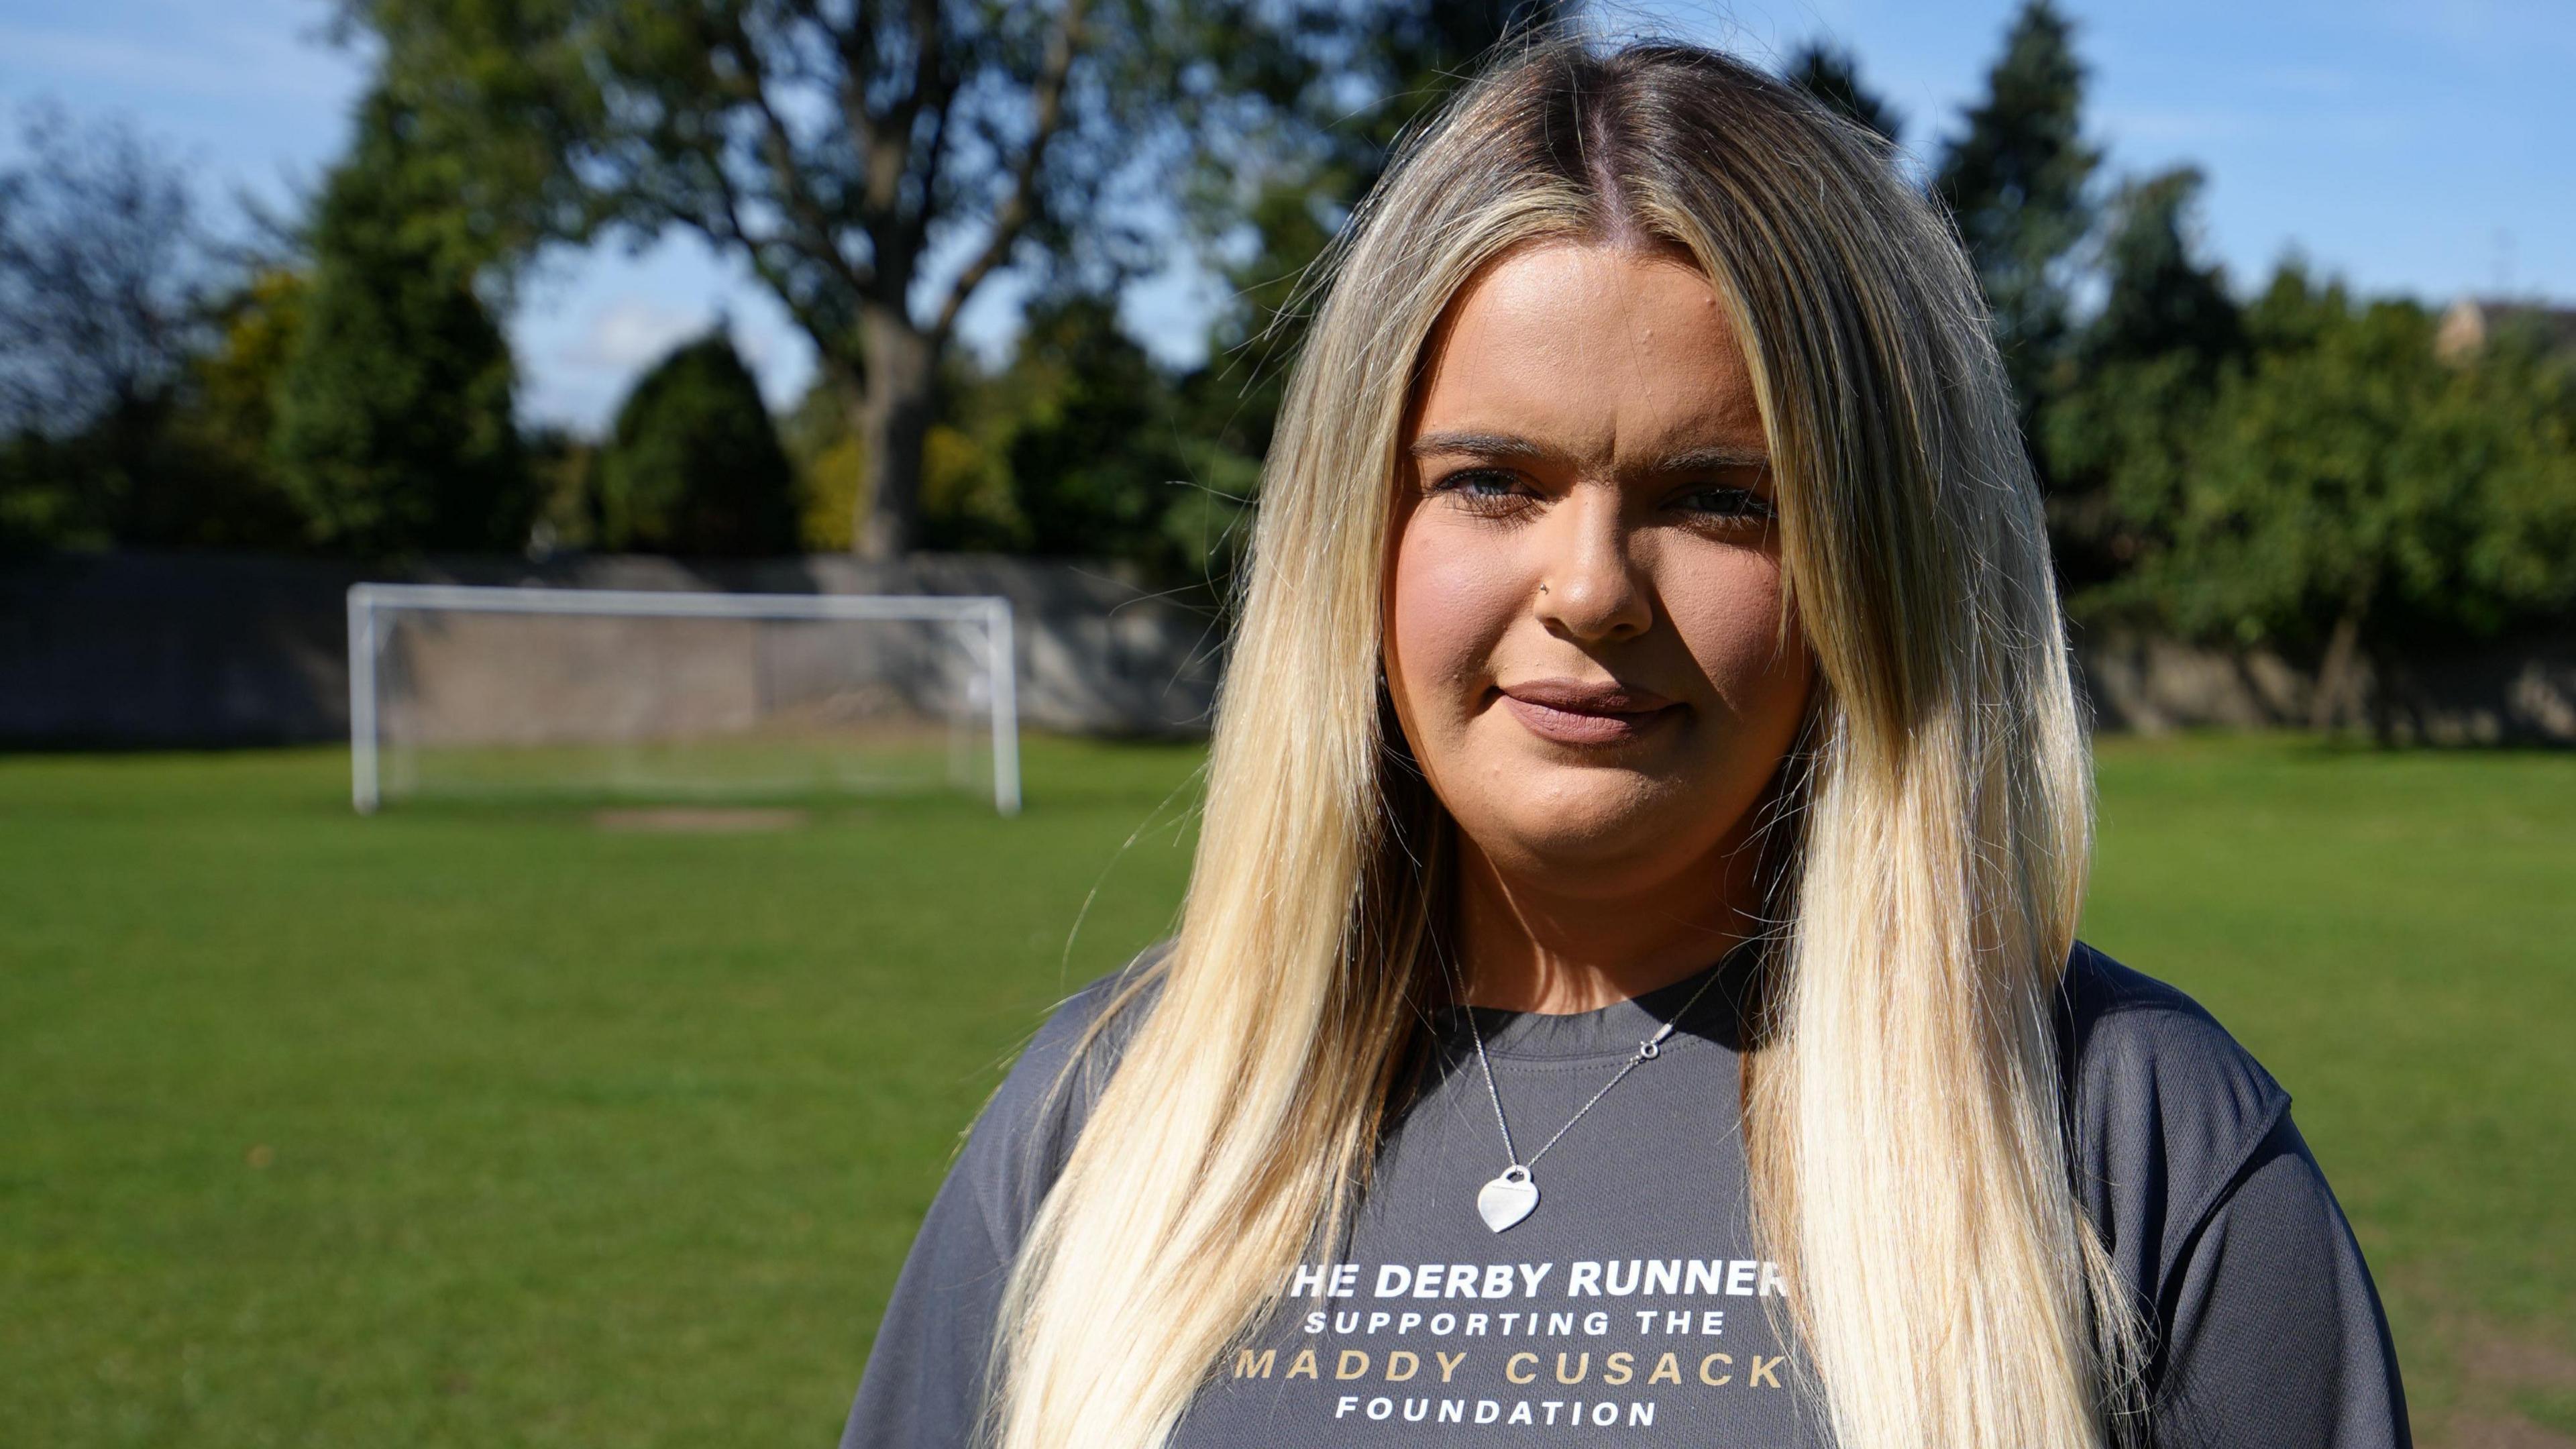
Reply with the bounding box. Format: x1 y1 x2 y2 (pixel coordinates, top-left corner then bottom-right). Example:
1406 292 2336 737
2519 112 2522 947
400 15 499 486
0 740 1198 1449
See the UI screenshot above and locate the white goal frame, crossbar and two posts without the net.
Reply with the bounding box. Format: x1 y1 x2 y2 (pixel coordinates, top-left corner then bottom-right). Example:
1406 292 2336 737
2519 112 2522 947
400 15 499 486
347 583 1020 815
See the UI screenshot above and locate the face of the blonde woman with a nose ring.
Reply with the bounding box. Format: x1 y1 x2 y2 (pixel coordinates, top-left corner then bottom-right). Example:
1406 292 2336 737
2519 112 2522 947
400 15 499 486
1386 242 1811 898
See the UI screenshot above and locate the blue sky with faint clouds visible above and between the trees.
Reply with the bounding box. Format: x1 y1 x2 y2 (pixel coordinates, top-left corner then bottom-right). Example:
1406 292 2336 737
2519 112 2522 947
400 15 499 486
0 0 2576 428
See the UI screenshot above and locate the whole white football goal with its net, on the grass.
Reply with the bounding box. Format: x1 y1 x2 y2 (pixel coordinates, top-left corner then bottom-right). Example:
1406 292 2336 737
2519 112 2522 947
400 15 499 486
347 583 1020 815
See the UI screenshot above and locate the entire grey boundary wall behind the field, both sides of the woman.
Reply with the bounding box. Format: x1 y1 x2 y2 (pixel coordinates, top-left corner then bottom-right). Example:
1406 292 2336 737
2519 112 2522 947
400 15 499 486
0 551 2576 748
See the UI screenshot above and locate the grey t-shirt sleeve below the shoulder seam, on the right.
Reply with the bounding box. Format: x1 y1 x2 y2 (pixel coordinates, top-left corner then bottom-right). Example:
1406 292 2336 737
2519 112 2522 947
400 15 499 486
2156 1114 2411 1449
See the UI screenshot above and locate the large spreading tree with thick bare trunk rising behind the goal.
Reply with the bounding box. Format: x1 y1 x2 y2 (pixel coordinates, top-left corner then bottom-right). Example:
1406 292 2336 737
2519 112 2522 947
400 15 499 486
345 0 1298 557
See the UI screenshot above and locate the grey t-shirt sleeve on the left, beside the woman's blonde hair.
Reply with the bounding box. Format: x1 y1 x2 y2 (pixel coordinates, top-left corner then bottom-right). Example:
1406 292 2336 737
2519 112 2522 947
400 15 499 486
840 949 1154 1449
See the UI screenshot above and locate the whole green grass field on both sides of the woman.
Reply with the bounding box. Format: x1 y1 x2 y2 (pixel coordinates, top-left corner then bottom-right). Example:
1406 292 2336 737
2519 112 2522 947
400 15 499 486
0 740 2576 1449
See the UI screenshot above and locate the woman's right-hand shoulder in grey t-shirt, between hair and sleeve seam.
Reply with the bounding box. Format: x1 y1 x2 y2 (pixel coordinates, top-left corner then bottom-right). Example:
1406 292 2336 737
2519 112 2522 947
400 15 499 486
2058 941 2290 1287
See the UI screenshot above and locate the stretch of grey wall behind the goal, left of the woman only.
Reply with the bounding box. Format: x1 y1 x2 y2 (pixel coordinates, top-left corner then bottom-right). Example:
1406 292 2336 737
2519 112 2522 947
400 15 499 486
0 551 1218 748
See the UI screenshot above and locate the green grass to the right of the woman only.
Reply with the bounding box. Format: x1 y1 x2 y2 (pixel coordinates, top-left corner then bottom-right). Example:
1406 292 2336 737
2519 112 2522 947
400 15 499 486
2084 740 2576 1444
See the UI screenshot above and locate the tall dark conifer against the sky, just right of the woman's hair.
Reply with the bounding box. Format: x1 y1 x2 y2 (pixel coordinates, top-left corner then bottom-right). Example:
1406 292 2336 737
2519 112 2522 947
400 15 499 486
1932 0 2100 428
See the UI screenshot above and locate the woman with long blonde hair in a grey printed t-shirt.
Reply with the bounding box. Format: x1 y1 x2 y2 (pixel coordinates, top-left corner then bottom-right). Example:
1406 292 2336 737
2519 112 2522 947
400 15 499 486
845 41 2406 1449
